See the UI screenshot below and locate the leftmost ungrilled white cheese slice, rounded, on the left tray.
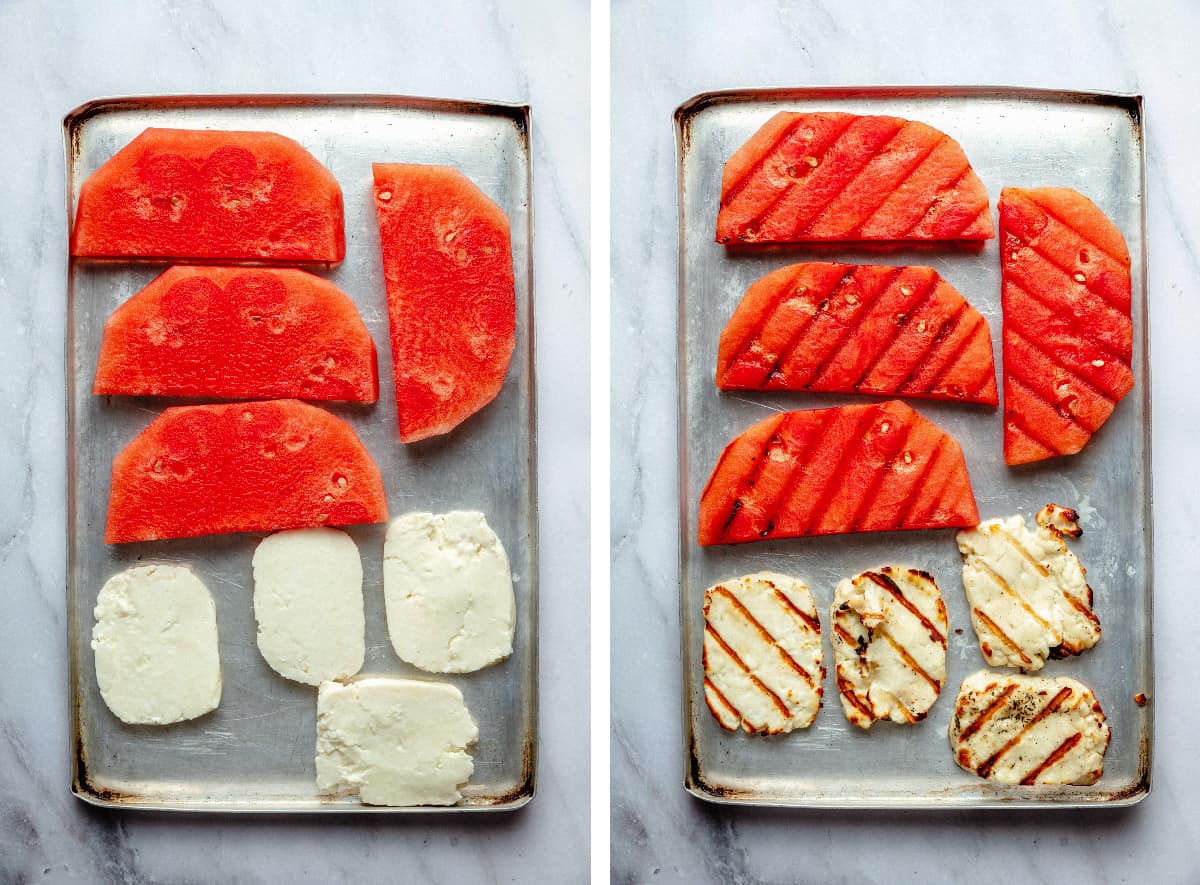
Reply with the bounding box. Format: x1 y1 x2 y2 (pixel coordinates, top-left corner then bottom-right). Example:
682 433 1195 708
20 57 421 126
91 565 221 726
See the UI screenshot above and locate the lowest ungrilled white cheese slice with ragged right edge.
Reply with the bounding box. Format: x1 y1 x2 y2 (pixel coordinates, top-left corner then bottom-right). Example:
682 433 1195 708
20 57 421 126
317 676 479 805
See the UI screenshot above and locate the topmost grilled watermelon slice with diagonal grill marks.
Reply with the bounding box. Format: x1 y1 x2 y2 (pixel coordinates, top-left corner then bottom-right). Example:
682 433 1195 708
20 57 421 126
716 112 994 245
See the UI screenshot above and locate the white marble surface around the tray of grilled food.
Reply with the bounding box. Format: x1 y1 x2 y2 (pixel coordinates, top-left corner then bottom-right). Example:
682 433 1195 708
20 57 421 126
611 0 1200 885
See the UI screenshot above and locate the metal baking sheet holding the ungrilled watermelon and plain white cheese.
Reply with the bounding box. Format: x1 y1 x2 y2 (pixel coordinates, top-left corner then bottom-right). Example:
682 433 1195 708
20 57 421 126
64 96 538 812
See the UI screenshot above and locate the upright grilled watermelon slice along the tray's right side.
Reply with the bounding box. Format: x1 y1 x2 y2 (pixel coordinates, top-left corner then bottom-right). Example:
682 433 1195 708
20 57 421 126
1000 187 1133 464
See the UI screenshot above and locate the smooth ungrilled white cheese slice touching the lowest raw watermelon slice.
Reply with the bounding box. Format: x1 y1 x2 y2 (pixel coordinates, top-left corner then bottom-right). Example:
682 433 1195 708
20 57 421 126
253 528 366 685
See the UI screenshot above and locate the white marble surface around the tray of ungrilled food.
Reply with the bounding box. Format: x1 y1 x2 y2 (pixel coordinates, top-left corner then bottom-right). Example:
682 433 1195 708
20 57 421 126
0 0 588 883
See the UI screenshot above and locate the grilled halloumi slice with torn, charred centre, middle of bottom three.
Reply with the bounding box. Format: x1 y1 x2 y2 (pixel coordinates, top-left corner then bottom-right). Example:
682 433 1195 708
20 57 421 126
829 566 949 728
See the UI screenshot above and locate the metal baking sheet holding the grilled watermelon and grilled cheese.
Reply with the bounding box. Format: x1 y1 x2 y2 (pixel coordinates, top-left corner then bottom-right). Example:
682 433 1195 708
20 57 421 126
676 88 1153 808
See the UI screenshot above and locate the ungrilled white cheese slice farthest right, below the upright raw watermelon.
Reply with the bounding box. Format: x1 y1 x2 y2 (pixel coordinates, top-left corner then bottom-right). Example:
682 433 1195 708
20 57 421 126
383 511 516 673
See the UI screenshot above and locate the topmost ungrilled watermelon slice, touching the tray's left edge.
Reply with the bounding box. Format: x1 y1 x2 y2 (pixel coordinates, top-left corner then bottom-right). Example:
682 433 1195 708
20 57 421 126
71 128 346 263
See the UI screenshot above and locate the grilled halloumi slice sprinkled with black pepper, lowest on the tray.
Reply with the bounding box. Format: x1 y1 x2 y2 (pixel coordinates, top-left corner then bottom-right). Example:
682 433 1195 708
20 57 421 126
949 670 1111 785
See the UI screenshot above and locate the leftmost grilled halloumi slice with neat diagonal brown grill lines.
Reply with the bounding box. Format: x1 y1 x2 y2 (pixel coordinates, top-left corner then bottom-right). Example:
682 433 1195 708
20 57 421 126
704 572 824 734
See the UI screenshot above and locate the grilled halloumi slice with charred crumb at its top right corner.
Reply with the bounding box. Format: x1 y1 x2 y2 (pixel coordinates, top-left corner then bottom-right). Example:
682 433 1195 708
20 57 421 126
958 505 1100 670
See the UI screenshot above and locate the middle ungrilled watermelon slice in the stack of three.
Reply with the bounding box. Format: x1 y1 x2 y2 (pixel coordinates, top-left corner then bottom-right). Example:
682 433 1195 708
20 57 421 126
92 266 379 403
